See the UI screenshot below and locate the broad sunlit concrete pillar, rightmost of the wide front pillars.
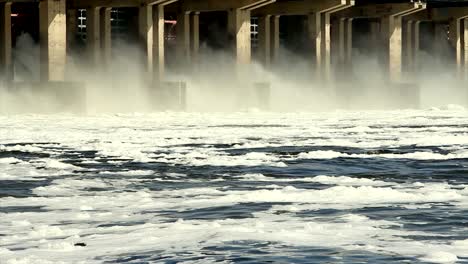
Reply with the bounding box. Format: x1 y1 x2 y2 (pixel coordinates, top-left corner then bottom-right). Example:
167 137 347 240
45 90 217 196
382 16 403 81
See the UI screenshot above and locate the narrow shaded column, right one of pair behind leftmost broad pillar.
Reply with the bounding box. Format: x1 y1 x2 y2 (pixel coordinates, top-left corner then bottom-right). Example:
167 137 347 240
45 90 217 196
99 7 112 66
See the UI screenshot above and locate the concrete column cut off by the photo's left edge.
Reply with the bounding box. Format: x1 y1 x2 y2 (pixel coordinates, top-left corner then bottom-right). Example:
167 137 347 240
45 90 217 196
0 2 13 81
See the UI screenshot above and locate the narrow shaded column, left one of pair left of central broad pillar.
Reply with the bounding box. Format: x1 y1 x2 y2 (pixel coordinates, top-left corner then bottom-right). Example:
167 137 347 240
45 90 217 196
176 12 191 67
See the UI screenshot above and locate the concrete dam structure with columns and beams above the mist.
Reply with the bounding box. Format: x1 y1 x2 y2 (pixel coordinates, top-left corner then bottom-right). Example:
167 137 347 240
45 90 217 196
0 0 468 109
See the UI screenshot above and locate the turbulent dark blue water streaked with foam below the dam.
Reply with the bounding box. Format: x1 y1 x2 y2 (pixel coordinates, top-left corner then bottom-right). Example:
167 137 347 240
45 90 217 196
0 107 468 264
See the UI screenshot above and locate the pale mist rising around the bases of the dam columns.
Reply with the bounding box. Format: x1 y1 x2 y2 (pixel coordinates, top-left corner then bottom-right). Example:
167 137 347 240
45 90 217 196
0 19 468 114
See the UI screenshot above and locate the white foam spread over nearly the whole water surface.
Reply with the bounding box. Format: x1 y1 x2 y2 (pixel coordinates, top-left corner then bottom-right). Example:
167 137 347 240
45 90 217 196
0 111 468 264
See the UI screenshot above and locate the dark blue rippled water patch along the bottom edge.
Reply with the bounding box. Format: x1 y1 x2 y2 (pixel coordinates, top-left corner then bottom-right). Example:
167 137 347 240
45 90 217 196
101 240 422 264
